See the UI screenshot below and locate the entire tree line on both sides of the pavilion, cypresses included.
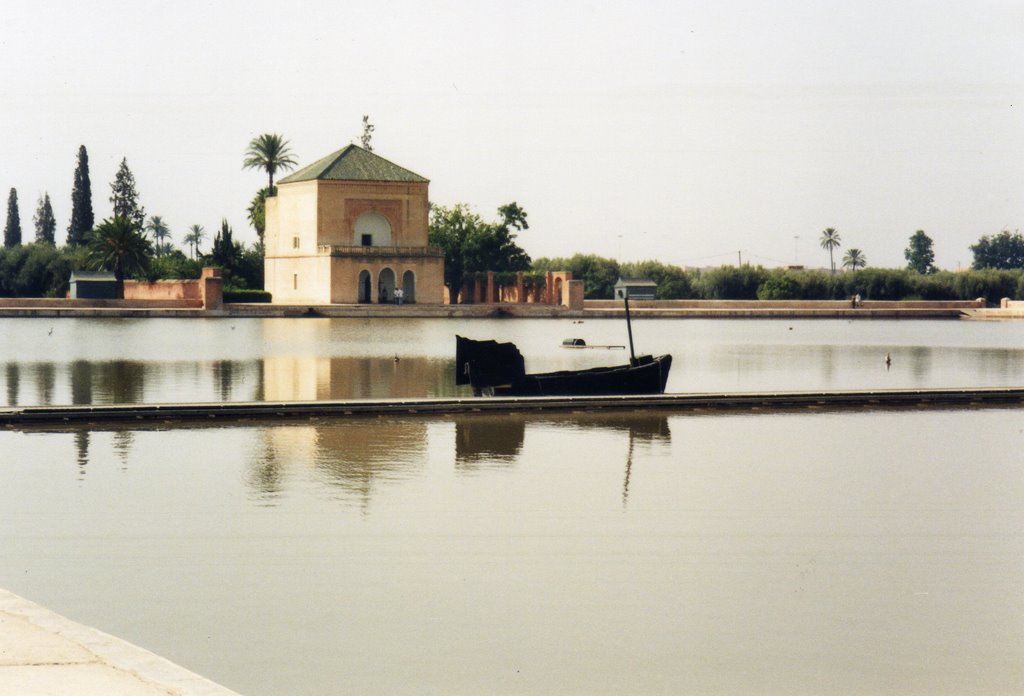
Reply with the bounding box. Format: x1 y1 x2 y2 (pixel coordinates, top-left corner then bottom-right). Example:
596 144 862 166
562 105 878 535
0 130 1024 302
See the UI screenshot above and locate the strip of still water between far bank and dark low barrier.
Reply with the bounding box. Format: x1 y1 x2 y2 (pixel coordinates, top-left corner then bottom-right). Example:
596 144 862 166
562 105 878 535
0 318 1024 405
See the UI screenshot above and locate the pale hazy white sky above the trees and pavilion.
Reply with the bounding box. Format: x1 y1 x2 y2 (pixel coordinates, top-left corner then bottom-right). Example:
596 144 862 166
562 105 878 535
0 0 1024 269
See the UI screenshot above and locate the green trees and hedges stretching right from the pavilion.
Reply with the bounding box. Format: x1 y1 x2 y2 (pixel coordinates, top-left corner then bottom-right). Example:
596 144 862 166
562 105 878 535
430 202 1024 304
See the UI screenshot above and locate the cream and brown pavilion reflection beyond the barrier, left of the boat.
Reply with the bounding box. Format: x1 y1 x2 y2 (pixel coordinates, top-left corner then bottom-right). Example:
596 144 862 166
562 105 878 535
263 356 455 401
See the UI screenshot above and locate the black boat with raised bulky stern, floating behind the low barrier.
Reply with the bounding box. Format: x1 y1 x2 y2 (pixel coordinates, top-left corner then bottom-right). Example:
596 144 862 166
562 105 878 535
456 336 672 396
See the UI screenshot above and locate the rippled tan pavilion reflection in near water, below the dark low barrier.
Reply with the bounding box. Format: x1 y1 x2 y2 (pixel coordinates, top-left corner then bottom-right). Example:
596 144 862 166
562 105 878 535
260 418 427 506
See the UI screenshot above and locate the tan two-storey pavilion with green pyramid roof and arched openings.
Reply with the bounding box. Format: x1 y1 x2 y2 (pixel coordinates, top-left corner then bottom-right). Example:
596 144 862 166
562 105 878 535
263 144 444 304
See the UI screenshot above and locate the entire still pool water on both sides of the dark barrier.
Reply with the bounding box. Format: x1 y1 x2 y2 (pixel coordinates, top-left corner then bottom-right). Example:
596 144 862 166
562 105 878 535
0 319 1024 694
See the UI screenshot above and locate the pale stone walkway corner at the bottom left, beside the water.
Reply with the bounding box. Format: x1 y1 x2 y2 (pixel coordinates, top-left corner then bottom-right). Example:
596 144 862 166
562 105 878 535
0 590 236 696
